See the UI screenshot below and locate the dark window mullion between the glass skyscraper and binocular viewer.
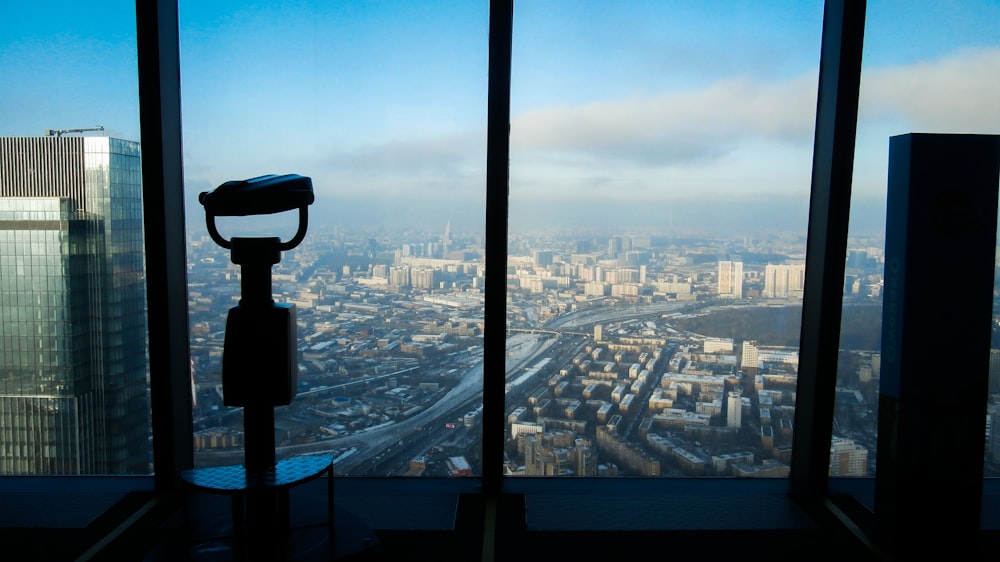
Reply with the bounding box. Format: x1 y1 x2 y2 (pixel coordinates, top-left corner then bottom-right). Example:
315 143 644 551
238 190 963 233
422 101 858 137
135 0 194 492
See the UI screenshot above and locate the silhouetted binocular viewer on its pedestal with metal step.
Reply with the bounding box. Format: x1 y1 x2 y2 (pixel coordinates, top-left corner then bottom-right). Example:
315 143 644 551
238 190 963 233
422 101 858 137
181 175 378 562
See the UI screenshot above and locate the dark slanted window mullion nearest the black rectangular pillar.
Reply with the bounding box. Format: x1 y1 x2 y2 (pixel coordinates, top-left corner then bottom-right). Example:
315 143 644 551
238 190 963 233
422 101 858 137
790 0 865 498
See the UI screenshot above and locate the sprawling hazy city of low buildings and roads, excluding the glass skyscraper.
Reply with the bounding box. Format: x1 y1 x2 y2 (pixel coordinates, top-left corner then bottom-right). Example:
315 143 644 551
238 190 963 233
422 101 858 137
188 212 896 476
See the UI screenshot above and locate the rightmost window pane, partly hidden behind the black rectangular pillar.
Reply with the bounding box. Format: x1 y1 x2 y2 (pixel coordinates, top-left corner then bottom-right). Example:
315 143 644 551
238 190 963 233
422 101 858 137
830 0 1000 476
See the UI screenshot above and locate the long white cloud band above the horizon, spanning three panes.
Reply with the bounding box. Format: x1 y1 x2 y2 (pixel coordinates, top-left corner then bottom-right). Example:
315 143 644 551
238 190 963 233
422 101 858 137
188 43 1000 206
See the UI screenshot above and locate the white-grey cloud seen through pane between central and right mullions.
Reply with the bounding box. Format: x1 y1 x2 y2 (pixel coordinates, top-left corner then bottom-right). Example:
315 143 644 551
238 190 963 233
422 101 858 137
511 71 816 166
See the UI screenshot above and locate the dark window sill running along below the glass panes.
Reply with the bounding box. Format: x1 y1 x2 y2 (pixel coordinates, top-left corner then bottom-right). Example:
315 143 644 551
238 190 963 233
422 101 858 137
7 477 1000 560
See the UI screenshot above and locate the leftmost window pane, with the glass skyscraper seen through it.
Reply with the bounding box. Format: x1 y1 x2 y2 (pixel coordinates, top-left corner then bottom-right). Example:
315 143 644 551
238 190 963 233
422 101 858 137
0 2 152 475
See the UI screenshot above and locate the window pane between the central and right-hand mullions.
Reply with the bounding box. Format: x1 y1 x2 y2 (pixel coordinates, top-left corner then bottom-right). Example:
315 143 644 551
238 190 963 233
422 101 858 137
505 1 823 476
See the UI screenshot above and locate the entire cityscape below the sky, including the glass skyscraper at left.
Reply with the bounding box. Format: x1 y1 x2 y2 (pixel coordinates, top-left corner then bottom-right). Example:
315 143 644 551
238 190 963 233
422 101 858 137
7 135 1000 477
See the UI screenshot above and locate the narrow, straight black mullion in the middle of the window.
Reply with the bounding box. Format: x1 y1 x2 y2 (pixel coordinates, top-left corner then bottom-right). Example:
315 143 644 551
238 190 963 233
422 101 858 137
482 0 514 494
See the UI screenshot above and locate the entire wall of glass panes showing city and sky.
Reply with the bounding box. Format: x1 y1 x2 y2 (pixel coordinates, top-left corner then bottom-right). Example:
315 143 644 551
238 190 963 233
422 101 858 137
0 2 1000 556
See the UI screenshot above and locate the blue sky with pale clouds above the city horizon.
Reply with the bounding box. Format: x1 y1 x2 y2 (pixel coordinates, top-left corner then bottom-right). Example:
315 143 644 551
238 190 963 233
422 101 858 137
0 0 1000 234
